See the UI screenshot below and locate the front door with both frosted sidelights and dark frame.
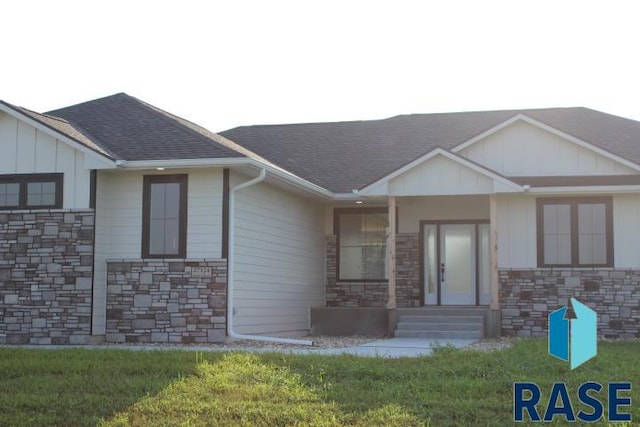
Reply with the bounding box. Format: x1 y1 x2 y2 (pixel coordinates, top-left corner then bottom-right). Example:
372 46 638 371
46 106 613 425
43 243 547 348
422 223 489 305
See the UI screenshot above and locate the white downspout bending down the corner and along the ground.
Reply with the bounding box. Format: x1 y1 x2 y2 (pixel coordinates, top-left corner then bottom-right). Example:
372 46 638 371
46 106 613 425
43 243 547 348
227 168 313 345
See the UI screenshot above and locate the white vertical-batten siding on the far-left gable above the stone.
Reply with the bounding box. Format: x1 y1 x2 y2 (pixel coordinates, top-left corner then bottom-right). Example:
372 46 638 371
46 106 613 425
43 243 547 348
0 112 91 209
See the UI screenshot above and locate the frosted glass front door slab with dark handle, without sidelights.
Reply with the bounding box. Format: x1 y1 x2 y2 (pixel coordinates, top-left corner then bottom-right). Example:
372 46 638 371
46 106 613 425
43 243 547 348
440 224 476 304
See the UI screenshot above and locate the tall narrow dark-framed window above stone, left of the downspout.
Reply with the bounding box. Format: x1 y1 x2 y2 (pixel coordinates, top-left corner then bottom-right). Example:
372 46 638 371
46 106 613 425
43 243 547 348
142 175 188 258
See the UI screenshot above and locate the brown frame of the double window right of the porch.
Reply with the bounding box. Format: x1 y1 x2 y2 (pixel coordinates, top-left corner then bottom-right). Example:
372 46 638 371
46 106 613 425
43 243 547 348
536 197 614 268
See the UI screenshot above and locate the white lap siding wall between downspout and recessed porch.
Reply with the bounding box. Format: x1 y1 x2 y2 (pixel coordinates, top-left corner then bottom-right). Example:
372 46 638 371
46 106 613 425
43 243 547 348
232 177 324 335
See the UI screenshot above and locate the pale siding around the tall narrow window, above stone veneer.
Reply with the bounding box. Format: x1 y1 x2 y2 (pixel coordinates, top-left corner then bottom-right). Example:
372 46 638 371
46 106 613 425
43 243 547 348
93 169 222 335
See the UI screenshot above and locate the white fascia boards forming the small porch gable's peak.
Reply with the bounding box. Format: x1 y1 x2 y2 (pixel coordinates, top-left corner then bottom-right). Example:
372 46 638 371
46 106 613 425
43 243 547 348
359 148 523 196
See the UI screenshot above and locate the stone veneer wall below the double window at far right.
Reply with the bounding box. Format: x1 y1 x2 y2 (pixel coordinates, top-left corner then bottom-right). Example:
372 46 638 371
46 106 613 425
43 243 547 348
499 269 640 338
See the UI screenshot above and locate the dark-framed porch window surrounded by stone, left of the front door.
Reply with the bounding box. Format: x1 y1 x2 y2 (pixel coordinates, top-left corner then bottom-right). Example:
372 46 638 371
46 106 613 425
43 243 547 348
334 208 389 281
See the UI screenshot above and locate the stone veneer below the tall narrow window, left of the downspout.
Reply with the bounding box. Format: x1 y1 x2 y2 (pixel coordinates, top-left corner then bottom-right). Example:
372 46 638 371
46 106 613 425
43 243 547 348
105 259 227 344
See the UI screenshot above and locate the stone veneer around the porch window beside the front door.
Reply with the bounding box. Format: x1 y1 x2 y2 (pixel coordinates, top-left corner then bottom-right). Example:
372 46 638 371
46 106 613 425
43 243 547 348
326 233 420 307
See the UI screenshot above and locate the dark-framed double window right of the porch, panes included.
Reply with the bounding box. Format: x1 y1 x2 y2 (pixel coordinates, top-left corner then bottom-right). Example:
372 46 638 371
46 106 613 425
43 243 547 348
537 197 613 267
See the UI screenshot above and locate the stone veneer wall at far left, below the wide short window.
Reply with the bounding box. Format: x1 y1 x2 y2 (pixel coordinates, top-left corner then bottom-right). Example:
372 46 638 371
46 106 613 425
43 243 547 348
0 209 94 344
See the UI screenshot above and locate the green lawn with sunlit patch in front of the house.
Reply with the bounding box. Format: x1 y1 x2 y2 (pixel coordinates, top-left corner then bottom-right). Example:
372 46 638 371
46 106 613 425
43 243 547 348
0 340 640 426
